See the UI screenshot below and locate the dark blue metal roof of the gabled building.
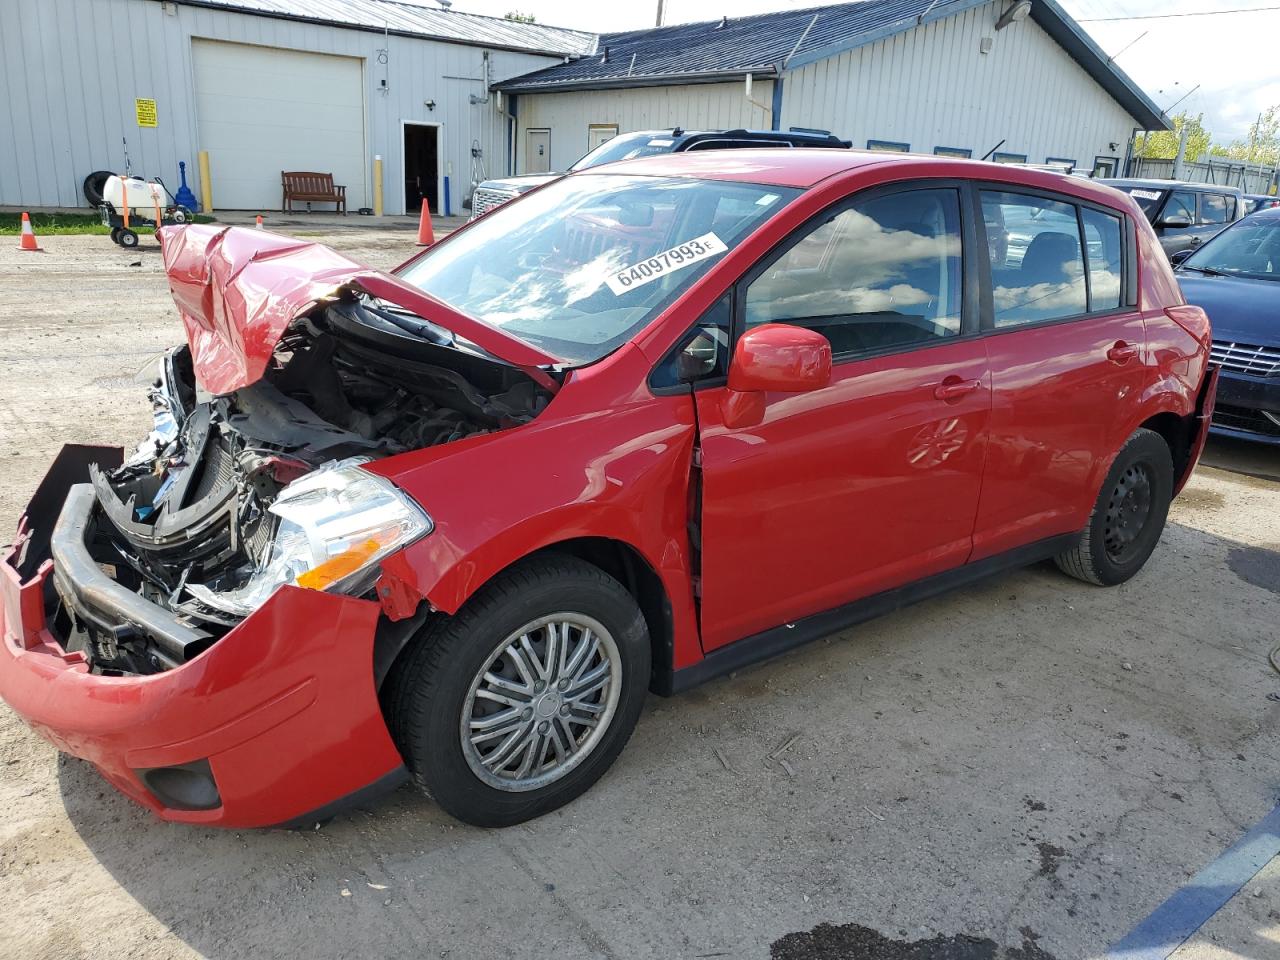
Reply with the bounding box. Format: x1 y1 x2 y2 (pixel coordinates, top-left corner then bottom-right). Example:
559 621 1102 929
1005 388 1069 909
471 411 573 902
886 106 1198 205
495 0 1169 129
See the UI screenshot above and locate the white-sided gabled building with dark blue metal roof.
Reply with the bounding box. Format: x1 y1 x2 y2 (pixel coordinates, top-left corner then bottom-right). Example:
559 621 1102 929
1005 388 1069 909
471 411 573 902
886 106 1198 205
497 0 1169 175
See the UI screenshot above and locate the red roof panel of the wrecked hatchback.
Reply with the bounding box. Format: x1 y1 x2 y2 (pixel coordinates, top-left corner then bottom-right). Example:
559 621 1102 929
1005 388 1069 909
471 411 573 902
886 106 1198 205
593 147 1157 210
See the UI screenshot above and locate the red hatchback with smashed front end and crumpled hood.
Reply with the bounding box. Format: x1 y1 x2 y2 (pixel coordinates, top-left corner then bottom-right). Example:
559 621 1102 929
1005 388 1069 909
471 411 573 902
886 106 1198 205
0 150 1215 827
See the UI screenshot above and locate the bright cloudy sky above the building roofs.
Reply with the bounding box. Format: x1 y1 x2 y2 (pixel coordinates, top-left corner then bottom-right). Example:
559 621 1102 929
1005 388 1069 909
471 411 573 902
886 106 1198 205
427 0 1280 143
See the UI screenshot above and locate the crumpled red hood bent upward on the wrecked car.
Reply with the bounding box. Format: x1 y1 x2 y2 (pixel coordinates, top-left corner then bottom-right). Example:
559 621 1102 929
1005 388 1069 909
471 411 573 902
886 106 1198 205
160 224 558 394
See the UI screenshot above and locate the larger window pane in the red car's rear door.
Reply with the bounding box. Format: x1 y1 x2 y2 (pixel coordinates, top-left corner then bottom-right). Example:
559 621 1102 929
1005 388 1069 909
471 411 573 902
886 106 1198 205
982 191 1088 328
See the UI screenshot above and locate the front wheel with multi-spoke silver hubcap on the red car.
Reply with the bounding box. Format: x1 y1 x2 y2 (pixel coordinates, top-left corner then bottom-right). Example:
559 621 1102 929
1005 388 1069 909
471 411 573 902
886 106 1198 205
383 553 650 827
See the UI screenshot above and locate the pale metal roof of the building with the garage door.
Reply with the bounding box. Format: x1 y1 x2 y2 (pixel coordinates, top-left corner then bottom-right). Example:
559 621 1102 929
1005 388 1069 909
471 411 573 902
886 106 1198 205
162 0 595 56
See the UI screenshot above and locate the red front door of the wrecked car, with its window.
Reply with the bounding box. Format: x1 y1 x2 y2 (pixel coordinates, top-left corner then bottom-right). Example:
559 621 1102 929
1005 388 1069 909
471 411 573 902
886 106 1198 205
696 182 991 650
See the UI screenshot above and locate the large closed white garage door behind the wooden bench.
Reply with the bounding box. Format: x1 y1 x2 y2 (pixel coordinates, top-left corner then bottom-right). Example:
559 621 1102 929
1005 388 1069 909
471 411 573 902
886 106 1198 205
192 40 367 210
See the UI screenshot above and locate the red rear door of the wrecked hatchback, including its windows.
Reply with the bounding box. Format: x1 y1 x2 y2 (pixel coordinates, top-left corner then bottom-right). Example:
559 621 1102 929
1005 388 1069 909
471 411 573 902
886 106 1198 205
973 191 1149 559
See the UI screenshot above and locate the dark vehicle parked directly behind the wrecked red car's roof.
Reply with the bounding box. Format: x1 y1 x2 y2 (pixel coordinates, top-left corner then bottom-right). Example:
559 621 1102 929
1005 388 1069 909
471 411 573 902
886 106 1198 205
471 127 852 220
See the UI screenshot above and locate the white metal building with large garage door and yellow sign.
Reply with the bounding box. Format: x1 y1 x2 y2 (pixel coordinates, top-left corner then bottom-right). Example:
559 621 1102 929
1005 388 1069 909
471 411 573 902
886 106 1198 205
0 0 595 214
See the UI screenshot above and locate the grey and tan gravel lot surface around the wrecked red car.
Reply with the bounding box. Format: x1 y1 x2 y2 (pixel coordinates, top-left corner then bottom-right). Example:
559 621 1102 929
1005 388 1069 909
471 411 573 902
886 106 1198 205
0 227 1280 960
